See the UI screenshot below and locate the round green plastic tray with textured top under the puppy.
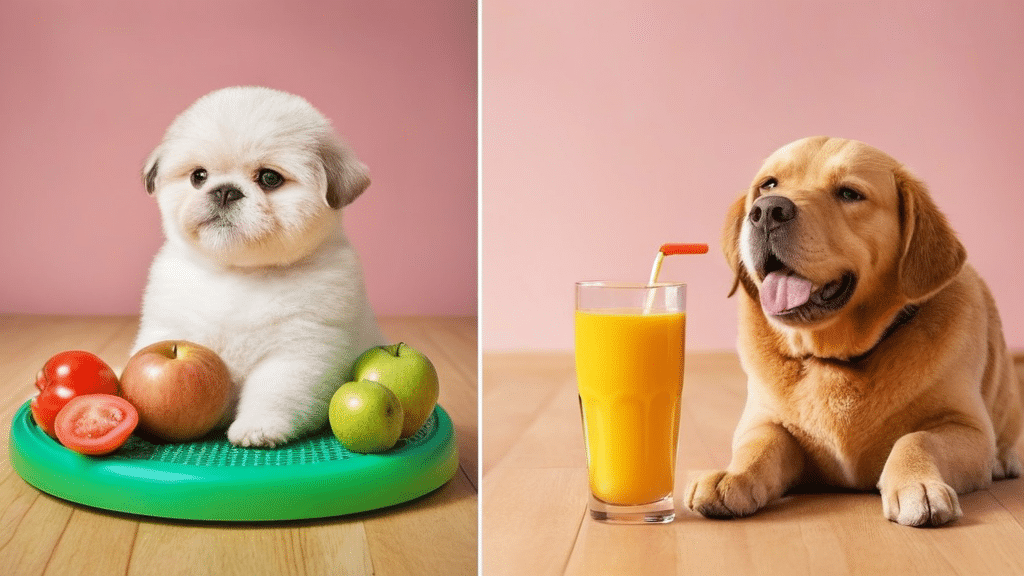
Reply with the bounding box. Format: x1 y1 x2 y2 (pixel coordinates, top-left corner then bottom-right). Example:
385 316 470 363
10 402 459 522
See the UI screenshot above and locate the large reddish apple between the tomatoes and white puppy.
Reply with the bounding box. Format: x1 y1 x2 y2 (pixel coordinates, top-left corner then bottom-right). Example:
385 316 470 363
121 340 231 442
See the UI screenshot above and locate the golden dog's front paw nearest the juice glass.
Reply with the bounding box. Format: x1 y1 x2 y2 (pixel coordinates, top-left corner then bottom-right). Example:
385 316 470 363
683 470 768 518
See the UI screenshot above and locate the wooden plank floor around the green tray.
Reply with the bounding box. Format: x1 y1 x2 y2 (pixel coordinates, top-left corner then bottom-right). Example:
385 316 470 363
0 316 478 576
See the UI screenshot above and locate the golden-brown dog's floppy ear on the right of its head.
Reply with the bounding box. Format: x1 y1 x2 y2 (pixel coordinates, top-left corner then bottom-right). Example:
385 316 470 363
895 167 967 301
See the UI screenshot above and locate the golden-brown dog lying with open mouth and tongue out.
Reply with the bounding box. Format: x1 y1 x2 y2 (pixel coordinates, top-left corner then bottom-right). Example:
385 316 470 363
684 137 1022 526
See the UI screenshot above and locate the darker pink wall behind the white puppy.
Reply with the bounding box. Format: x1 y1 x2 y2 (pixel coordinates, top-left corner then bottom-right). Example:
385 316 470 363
0 0 477 315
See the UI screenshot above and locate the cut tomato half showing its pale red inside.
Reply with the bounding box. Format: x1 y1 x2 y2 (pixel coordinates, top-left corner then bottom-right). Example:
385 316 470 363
53 394 138 456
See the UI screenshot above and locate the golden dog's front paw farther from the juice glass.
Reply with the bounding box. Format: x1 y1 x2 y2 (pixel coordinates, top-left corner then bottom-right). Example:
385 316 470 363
882 481 964 526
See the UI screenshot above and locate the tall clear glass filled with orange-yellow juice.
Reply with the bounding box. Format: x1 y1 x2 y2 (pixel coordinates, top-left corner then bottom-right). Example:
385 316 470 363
575 282 686 524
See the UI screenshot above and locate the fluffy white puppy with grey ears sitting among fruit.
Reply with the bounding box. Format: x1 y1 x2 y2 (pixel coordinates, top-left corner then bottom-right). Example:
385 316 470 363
132 87 383 447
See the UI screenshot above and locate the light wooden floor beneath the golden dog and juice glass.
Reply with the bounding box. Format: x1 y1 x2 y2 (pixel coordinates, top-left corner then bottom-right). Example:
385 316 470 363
481 353 1024 576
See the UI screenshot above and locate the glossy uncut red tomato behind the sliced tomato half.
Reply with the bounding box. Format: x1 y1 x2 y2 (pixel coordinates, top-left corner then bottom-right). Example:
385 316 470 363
30 351 118 437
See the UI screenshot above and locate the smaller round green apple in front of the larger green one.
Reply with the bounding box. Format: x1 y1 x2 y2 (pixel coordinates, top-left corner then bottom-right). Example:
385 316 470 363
330 380 404 454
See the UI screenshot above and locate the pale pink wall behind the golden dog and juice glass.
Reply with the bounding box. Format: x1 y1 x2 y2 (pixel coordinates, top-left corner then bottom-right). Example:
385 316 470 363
481 0 1024 349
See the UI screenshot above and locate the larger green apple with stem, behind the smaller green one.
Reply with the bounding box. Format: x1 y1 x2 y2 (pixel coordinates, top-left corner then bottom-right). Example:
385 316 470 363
352 342 440 438
